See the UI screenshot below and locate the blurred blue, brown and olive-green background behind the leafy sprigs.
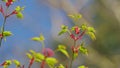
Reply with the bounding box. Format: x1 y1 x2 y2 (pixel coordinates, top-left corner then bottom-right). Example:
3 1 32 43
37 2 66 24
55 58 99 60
0 0 120 68
